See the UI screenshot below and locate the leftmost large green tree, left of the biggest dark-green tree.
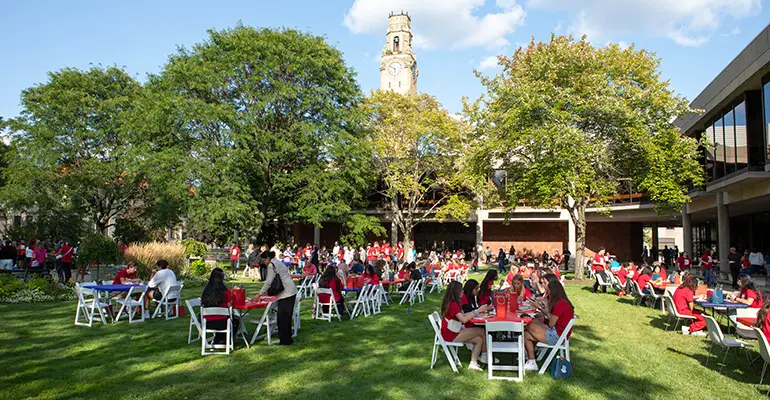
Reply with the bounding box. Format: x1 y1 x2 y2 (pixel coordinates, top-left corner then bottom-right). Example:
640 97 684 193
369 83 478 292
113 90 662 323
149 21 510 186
2 67 176 239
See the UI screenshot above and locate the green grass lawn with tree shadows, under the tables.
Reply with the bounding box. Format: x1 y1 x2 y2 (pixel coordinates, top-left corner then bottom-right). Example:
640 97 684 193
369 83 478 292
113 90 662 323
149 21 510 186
0 277 763 400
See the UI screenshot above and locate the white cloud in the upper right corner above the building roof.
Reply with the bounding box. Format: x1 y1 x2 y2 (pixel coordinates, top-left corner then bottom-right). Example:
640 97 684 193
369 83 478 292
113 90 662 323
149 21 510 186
528 0 762 46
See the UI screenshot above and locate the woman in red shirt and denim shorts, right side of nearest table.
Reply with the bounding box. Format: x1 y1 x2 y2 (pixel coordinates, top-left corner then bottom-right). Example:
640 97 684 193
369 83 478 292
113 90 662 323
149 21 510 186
524 281 575 371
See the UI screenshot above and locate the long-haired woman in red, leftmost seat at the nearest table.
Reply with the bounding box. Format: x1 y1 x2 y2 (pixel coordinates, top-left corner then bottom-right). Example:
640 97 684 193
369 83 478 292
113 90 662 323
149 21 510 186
441 281 486 371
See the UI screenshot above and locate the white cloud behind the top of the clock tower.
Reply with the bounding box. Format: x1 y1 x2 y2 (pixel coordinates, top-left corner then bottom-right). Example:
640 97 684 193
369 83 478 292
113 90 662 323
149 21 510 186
343 0 525 49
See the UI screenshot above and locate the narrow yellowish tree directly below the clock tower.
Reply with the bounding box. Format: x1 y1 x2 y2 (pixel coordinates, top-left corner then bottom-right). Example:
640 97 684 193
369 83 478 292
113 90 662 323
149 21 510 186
364 90 473 254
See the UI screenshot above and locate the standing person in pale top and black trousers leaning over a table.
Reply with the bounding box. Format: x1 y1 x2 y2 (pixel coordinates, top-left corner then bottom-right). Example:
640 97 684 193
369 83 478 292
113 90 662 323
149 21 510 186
257 251 297 346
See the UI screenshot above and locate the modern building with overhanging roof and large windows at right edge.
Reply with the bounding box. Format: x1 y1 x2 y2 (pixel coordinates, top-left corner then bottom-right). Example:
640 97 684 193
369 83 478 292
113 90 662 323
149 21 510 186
676 25 770 270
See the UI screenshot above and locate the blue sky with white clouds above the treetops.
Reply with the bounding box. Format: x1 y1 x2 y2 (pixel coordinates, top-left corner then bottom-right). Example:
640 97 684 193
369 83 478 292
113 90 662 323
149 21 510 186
0 0 770 118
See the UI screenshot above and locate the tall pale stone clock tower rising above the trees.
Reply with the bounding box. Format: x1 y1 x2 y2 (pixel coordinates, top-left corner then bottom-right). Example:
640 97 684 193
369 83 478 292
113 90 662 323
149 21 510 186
380 12 419 94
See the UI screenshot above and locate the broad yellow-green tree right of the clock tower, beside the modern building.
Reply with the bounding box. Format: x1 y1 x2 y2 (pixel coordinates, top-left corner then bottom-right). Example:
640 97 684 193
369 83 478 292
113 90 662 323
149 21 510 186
466 36 703 279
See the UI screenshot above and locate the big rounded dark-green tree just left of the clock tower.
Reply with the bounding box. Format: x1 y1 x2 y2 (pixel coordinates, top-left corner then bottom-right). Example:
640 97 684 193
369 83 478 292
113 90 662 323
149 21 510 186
144 26 371 241
